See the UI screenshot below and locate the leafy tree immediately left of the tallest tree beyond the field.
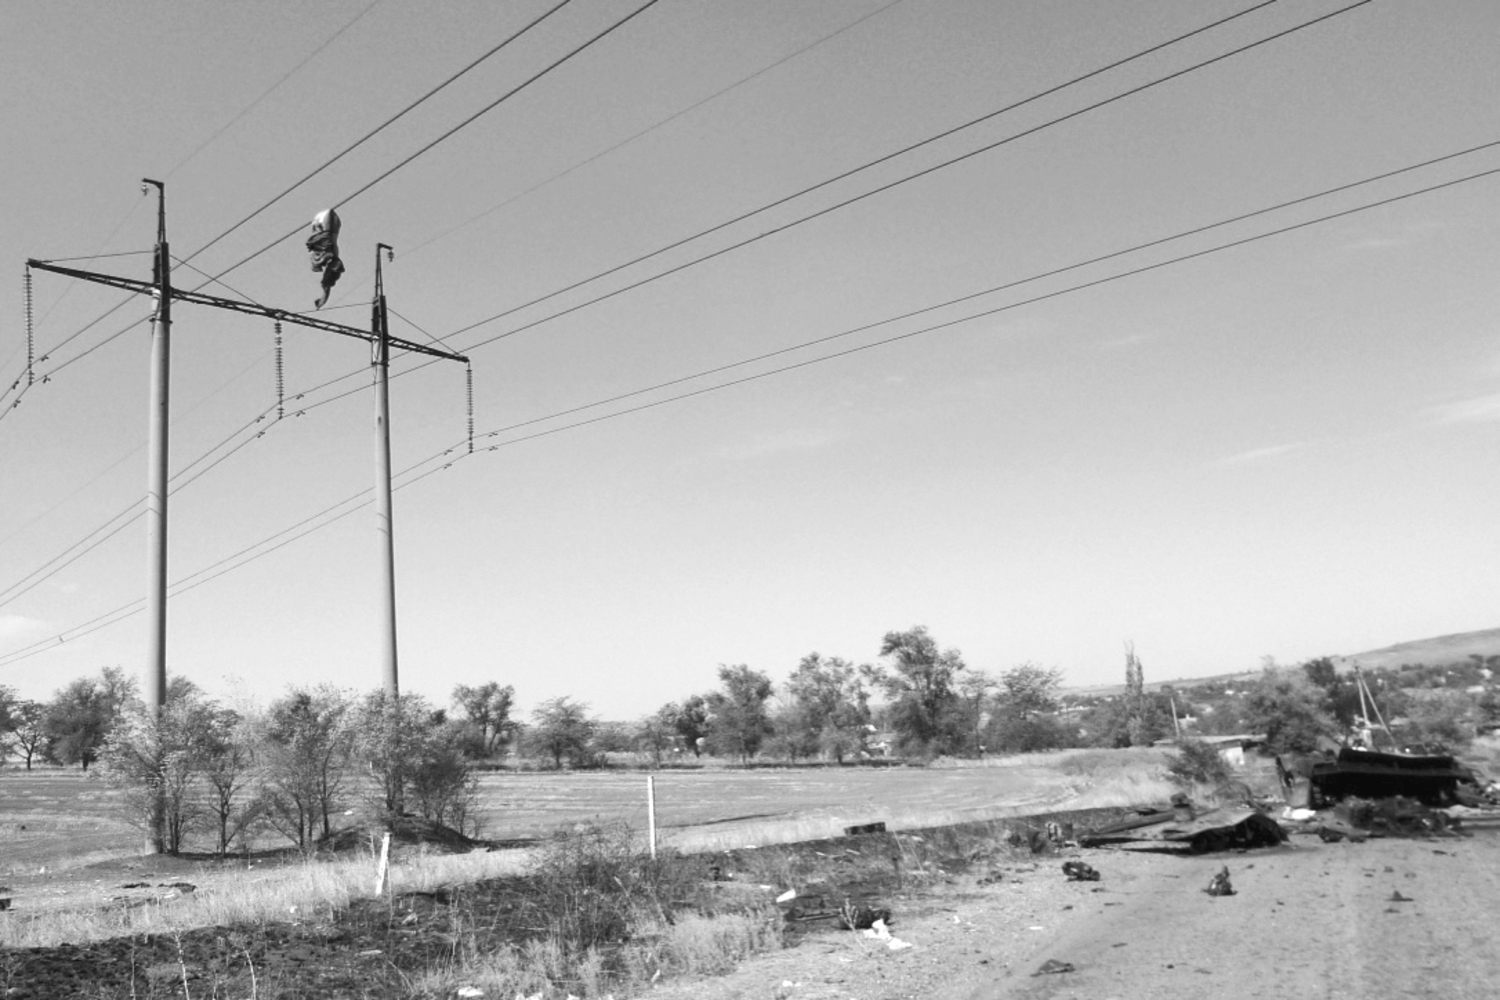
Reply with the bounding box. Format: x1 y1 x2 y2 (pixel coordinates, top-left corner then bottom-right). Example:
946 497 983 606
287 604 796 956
777 652 870 763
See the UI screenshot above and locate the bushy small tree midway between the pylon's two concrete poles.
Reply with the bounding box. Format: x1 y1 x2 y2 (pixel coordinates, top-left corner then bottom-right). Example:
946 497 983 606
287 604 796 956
255 687 354 852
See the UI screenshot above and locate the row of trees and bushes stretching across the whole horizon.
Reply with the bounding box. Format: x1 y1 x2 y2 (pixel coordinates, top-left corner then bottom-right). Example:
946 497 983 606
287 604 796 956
0 625 1500 852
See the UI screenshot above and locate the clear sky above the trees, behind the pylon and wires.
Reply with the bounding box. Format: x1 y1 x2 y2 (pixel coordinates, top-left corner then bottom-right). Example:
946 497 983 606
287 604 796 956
0 0 1500 718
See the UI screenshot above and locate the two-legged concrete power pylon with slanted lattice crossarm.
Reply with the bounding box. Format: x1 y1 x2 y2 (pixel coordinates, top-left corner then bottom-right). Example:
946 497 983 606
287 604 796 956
26 187 474 853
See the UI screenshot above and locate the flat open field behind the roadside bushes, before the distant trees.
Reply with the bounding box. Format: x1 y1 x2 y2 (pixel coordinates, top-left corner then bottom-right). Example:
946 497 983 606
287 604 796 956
0 751 1164 877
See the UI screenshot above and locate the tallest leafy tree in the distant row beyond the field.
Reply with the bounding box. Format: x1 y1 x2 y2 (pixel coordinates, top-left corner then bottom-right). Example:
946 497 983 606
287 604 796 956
869 625 966 754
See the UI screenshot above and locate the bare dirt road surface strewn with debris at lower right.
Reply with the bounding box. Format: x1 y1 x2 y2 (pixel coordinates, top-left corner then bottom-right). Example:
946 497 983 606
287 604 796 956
650 831 1500 1000
